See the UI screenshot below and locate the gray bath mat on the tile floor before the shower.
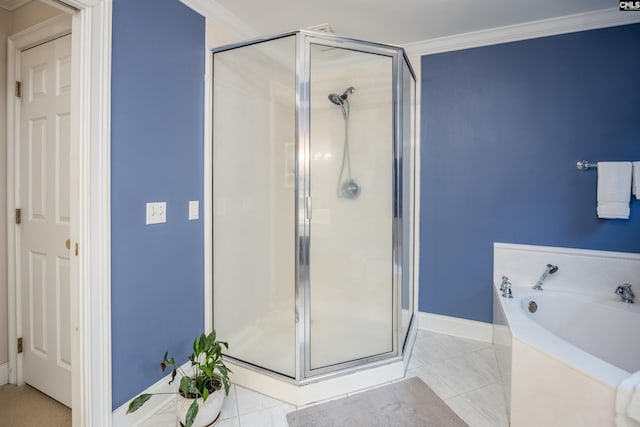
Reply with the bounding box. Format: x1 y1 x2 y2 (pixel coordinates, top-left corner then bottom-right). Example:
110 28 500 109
287 377 467 427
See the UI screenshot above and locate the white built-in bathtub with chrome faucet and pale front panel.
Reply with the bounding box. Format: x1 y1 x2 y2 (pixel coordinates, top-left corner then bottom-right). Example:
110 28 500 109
493 243 640 427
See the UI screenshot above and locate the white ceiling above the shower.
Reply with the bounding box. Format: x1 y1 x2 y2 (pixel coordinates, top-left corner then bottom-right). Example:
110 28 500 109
210 0 617 45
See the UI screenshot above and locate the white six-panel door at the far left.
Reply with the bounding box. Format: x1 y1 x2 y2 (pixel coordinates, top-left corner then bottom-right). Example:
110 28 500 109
17 35 71 407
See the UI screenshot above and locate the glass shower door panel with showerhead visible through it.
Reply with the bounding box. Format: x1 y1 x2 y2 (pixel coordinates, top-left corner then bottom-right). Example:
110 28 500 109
309 43 394 370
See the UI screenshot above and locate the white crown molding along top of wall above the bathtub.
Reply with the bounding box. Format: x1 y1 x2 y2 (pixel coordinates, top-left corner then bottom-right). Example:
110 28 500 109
404 7 640 55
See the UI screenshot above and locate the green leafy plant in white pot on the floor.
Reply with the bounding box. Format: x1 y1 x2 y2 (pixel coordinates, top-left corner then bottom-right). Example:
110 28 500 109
127 331 231 427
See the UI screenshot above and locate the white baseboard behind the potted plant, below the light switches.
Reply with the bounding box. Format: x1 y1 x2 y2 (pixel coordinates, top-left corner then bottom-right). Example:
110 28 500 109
111 362 191 427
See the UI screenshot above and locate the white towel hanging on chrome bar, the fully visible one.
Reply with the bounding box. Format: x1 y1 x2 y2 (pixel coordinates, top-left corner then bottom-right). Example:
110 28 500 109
598 162 631 219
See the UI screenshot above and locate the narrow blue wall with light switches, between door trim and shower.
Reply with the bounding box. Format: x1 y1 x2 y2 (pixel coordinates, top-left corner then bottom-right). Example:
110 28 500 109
111 0 205 408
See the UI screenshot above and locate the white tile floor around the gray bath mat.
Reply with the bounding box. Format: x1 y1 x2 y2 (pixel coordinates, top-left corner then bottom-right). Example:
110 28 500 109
144 331 509 427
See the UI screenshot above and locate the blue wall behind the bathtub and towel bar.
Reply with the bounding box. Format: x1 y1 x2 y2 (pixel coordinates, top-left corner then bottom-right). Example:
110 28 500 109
419 24 640 322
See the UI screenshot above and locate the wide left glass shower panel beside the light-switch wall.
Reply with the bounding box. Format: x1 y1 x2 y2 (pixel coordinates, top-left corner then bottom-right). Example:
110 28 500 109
213 35 296 378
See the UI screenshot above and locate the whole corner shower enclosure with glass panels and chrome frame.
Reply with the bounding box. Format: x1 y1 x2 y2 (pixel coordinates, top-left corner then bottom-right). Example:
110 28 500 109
213 31 416 400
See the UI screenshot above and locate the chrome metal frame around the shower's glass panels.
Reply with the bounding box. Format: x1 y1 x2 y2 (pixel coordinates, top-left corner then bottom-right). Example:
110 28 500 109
212 30 417 385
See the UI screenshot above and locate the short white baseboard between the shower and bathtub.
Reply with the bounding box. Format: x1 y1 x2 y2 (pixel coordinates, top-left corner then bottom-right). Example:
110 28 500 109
418 312 493 342
